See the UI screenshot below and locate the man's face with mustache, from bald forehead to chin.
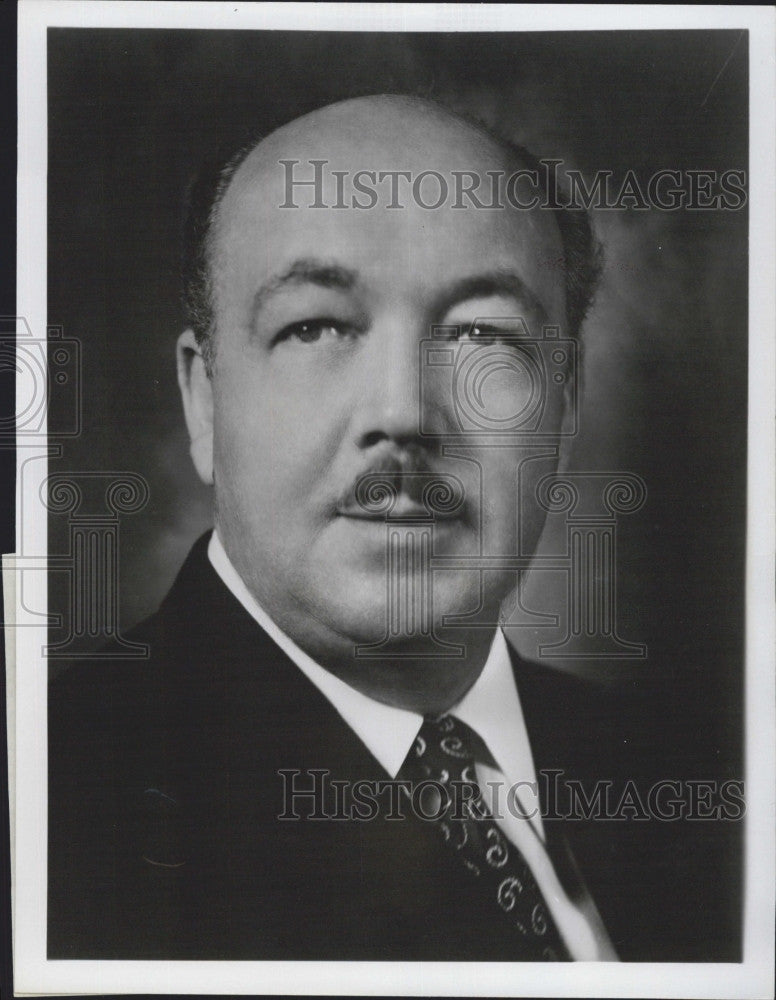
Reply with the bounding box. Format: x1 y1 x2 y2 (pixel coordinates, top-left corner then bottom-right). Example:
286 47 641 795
200 99 565 657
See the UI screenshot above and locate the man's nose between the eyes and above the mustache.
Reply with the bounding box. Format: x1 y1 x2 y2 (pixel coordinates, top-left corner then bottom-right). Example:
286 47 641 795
352 313 425 449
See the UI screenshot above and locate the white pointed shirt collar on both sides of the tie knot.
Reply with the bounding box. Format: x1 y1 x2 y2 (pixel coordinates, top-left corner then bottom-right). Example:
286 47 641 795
208 531 534 781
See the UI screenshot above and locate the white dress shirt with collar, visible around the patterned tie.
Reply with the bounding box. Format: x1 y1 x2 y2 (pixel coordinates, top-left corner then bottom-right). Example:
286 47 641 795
208 531 617 961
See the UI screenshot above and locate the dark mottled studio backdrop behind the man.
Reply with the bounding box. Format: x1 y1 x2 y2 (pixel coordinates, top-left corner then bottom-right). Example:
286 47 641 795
48 28 748 860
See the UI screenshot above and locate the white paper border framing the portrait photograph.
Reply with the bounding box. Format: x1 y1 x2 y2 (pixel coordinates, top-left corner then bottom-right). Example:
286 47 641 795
9 0 776 998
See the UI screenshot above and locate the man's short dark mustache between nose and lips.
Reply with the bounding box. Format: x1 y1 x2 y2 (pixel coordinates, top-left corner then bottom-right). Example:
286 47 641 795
337 452 467 520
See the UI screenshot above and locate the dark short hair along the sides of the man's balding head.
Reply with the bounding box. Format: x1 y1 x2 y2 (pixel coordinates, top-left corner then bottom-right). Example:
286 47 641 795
182 95 603 375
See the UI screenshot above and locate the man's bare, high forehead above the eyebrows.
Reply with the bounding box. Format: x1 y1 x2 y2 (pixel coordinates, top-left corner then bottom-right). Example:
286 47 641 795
213 99 563 313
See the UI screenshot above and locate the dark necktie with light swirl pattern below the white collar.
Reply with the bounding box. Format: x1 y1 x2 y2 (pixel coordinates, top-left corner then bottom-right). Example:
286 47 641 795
400 715 569 961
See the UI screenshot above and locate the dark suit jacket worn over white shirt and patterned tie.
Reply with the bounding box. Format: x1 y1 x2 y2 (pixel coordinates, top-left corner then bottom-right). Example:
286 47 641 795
48 536 735 961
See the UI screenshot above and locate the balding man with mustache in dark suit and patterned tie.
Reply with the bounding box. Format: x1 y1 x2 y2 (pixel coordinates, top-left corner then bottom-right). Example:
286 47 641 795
49 96 704 960
